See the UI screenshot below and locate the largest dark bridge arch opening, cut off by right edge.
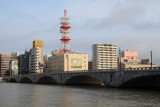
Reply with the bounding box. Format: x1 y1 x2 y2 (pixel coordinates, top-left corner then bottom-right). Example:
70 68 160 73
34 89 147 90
119 75 160 88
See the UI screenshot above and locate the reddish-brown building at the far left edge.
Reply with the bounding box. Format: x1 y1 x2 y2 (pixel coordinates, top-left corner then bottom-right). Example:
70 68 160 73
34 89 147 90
0 52 18 76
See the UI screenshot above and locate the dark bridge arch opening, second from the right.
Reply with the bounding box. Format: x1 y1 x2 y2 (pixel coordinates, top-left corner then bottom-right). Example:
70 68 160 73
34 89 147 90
65 75 103 85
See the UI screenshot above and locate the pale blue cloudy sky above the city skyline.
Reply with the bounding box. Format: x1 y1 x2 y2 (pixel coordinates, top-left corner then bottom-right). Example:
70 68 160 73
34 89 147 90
0 0 160 65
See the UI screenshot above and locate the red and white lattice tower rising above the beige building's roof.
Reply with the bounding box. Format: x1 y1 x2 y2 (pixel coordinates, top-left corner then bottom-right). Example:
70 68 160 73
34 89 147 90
59 10 72 54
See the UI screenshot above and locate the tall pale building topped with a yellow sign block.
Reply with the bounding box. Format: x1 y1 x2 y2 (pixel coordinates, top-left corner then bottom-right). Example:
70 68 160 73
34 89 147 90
29 40 43 73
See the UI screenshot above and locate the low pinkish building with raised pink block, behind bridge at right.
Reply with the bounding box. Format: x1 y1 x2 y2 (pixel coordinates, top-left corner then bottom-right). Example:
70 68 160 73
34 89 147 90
118 50 157 69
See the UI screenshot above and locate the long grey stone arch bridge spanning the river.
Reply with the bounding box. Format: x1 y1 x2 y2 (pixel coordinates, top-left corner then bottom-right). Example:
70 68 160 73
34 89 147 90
3 67 160 87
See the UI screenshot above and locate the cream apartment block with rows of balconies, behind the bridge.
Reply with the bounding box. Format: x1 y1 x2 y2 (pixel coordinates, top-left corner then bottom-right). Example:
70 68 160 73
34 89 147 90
92 44 117 69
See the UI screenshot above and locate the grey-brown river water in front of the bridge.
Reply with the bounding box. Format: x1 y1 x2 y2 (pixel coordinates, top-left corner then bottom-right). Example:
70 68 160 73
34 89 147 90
0 83 160 107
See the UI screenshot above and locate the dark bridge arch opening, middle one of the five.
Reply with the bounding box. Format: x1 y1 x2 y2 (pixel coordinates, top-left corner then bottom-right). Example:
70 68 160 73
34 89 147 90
37 76 57 84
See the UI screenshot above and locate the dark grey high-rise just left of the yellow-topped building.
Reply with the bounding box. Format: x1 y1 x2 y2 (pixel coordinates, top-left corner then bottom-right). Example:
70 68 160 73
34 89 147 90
18 51 29 74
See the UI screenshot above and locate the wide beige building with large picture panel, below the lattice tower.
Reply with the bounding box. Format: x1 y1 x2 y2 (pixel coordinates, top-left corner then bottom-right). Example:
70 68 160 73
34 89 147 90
48 52 88 72
